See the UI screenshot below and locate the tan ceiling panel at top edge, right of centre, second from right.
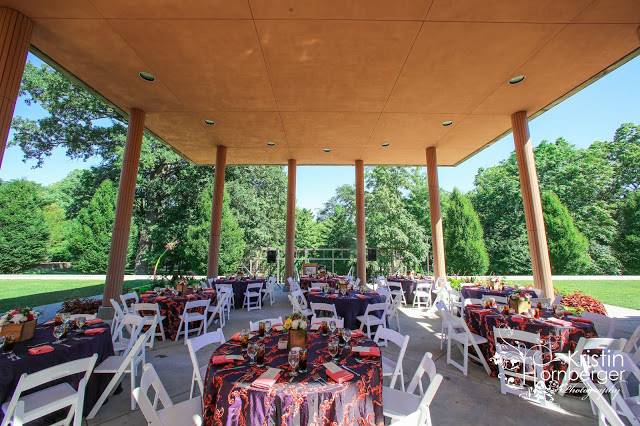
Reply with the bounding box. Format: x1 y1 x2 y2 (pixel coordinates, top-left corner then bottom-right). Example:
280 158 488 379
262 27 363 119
427 0 592 23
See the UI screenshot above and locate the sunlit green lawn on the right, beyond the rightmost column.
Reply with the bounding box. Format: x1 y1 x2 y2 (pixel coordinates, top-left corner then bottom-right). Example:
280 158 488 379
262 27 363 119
513 280 640 309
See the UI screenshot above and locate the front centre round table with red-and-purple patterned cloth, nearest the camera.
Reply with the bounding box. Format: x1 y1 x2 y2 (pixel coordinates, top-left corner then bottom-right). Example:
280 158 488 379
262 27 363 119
203 331 384 426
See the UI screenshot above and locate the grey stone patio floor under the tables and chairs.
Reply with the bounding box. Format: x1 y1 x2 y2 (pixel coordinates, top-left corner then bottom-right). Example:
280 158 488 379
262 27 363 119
87 291 640 426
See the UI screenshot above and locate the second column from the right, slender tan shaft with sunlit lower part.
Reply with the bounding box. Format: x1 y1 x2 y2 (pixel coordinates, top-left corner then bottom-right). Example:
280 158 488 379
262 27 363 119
426 146 447 279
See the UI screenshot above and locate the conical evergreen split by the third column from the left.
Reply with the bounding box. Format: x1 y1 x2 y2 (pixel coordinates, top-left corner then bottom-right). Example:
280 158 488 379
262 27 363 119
182 187 246 274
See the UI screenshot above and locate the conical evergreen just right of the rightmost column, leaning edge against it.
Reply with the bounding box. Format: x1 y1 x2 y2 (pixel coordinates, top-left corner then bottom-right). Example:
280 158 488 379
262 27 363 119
541 191 593 275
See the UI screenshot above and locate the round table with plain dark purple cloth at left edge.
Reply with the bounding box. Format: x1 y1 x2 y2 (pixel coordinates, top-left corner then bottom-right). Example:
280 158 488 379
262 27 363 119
0 323 113 424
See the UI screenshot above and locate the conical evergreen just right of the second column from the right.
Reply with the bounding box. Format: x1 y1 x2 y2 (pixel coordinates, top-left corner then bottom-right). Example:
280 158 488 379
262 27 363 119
444 189 489 275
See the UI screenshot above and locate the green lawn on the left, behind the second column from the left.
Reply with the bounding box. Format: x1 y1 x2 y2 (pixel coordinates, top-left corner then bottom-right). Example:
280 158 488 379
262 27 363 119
0 277 151 312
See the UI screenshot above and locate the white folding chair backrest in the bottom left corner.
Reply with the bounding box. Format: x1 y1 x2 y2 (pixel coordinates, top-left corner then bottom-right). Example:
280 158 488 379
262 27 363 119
2 354 98 424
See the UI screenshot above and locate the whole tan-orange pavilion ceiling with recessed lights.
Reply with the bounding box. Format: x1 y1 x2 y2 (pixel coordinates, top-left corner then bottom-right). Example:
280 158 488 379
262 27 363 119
5 0 640 165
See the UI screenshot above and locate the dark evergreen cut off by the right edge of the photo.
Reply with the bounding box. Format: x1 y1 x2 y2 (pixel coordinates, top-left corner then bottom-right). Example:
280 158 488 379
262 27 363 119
616 191 640 275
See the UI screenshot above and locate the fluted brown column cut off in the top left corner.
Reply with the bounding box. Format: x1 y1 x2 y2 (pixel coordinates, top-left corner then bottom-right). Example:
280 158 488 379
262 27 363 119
0 7 33 167
